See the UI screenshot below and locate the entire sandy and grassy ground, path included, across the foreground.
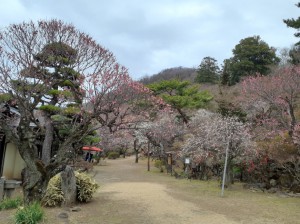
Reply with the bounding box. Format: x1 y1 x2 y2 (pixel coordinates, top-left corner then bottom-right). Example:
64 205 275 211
0 157 300 224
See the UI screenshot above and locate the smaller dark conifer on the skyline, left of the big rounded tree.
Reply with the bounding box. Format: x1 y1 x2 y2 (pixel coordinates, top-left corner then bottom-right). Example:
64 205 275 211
195 57 220 83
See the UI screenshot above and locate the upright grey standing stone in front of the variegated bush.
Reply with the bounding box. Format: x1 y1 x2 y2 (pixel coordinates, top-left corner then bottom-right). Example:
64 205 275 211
61 166 77 206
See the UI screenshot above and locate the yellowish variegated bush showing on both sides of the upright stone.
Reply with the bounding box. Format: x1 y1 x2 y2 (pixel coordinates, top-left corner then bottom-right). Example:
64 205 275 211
42 172 99 207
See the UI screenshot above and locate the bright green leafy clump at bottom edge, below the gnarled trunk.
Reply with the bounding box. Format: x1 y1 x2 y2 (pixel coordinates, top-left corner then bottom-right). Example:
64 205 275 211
14 202 44 224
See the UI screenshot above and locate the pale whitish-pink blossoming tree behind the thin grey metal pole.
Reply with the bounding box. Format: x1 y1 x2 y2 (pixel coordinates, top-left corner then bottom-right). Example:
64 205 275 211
182 110 255 186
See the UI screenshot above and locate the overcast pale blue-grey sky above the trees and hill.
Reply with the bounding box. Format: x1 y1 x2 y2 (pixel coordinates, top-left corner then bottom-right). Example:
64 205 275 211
0 0 300 79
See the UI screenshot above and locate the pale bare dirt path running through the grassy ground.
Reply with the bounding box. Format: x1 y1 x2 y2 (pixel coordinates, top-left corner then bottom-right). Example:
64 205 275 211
96 158 236 224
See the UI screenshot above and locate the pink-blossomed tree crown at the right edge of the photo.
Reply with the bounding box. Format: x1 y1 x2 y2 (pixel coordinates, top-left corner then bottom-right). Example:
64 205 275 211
243 66 300 136
